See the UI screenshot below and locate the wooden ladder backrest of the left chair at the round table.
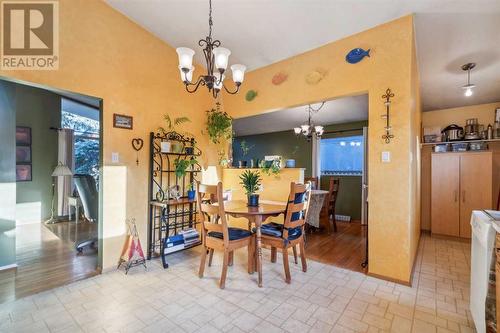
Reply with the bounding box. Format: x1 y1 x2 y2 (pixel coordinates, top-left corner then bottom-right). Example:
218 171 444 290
196 182 229 246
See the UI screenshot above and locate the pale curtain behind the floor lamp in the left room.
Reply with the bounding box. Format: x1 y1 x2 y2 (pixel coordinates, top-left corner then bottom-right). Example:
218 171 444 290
57 128 75 216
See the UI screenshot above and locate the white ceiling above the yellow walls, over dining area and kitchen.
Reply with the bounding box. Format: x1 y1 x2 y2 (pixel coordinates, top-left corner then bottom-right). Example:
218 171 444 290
106 0 500 110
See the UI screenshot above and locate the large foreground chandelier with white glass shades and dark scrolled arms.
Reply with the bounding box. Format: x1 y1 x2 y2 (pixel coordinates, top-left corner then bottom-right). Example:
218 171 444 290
176 0 246 98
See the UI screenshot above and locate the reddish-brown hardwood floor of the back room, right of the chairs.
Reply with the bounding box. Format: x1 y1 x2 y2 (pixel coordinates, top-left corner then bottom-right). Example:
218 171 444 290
306 221 367 273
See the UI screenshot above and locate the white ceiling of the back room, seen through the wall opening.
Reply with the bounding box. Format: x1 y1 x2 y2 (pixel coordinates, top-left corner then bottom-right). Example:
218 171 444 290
233 95 368 136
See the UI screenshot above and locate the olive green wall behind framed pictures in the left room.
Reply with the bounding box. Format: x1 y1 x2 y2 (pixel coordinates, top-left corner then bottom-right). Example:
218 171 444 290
16 84 61 221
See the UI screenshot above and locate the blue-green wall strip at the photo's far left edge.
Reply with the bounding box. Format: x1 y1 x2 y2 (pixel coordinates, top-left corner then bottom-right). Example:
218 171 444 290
0 81 16 267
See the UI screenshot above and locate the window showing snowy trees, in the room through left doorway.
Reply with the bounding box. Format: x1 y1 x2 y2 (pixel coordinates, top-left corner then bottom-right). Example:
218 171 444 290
61 99 99 181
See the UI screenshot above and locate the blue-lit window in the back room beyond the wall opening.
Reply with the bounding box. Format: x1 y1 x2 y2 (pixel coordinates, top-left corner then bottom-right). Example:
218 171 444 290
320 135 363 175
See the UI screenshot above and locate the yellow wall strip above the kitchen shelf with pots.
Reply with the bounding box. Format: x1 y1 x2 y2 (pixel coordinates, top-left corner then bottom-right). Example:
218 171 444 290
422 101 500 128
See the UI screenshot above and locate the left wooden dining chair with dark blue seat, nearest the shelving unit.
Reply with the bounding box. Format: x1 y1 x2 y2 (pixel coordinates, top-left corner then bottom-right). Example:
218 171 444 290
196 182 255 289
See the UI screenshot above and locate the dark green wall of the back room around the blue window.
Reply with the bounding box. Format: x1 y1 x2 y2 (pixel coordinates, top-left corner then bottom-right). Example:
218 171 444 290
233 121 368 220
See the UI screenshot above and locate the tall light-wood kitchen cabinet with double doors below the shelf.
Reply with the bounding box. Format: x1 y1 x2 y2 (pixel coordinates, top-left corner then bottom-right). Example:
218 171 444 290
431 151 493 238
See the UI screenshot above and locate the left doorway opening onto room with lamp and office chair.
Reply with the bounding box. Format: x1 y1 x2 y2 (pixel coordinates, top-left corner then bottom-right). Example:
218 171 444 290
0 79 102 303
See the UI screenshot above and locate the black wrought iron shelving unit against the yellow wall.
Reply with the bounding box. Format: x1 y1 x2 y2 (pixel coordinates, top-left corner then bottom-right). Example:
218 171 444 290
147 132 201 268
